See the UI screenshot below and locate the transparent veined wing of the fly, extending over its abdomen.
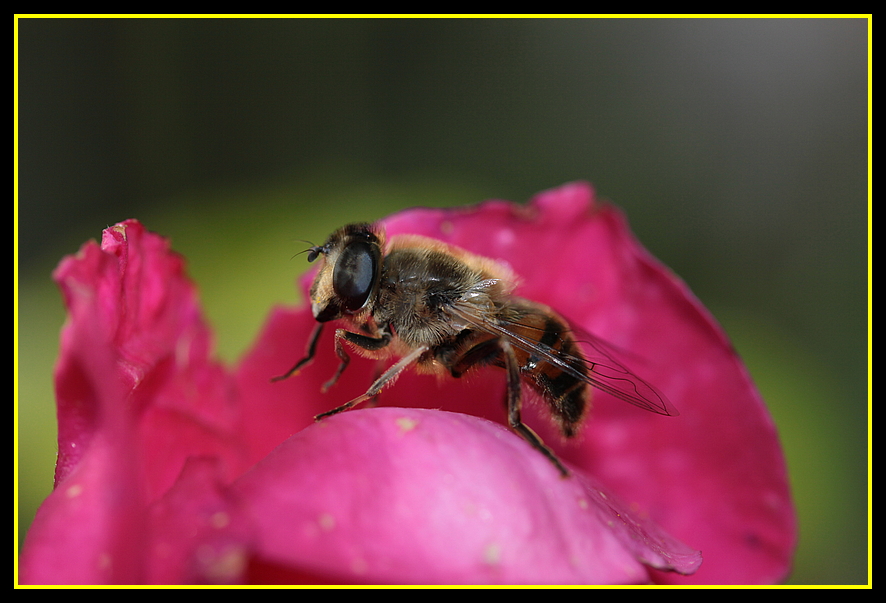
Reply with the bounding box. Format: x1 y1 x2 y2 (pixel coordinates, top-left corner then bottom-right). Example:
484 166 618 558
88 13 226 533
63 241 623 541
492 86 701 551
452 306 680 417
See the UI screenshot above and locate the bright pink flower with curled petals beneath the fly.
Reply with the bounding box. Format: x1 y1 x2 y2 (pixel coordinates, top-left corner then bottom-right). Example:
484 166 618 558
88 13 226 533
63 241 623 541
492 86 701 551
20 183 796 584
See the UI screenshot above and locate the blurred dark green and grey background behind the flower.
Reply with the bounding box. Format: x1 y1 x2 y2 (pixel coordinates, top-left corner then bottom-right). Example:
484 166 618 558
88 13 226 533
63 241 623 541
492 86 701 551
17 18 870 584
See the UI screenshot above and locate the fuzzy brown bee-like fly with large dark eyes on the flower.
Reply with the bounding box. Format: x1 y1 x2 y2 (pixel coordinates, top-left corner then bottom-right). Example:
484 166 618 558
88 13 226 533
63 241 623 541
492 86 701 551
273 223 678 476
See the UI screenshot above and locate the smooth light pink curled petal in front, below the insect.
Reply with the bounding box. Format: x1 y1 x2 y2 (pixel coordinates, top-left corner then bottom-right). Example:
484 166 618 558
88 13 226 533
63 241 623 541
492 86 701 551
234 408 698 584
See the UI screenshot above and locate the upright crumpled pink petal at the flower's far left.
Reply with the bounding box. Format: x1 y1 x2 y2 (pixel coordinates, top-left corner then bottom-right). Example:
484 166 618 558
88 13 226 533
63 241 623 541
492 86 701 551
20 221 245 584
